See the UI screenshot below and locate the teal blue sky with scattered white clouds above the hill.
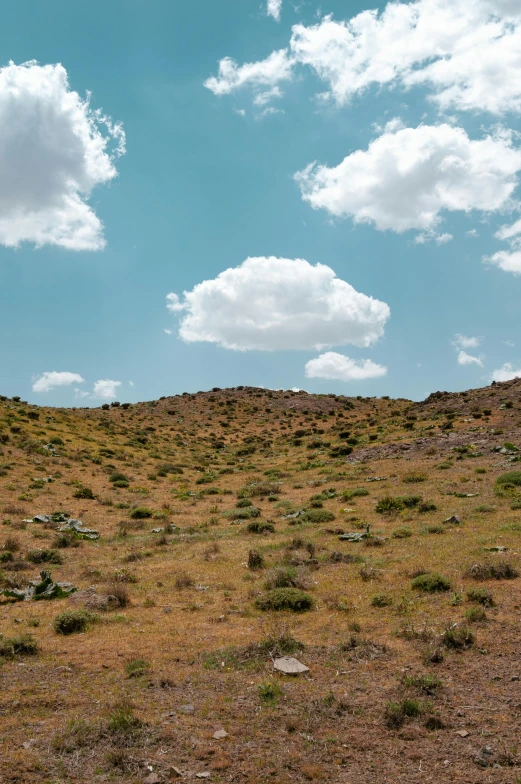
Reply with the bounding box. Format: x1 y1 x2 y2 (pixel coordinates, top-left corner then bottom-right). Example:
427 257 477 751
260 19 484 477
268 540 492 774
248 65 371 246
0 0 521 406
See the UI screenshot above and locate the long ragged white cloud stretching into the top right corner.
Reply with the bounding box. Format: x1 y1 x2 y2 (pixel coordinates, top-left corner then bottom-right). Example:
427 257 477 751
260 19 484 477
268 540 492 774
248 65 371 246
206 0 521 115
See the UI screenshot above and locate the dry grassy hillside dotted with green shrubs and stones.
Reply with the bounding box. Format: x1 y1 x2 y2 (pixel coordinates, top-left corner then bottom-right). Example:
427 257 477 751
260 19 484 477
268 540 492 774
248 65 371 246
0 379 521 784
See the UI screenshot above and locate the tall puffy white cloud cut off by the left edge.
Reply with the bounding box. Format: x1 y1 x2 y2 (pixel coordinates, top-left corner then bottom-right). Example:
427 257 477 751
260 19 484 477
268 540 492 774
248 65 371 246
0 61 125 250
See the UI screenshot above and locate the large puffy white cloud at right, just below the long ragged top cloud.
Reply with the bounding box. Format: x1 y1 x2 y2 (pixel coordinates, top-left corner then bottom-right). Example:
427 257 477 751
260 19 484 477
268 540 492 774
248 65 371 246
295 123 521 234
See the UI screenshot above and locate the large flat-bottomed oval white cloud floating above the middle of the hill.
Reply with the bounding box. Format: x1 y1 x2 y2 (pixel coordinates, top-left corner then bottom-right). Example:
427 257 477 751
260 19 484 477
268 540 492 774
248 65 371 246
167 256 390 351
